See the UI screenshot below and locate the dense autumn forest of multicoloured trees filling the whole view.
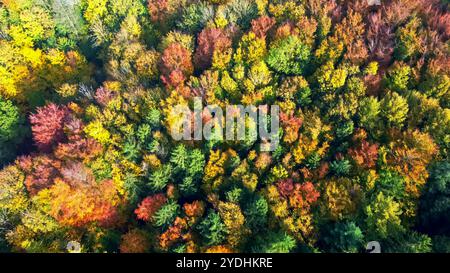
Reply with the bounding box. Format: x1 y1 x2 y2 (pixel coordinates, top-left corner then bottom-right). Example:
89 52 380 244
0 0 450 253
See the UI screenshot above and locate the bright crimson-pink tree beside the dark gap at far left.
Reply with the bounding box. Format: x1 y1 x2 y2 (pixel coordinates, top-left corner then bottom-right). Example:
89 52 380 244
30 103 69 152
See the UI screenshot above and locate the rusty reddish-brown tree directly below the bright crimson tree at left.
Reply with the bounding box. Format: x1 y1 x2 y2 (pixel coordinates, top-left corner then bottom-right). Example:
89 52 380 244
18 155 61 195
